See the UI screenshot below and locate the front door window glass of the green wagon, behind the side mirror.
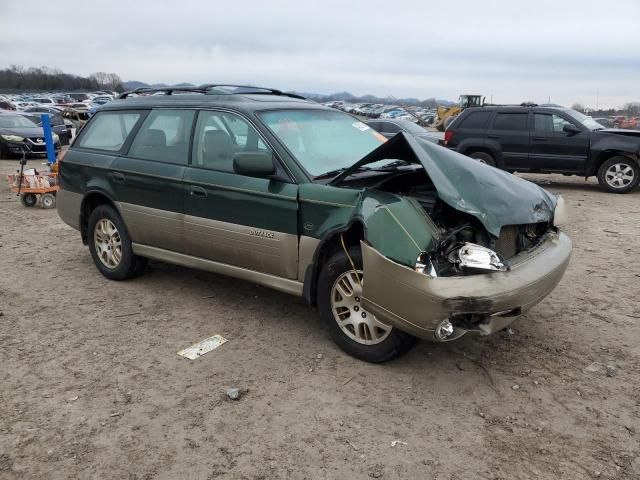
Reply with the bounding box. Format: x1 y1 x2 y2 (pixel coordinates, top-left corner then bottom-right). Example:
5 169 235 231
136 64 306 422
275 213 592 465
191 111 269 172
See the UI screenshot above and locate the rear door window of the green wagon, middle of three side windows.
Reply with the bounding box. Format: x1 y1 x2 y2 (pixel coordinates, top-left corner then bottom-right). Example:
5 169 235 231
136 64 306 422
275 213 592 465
129 110 195 164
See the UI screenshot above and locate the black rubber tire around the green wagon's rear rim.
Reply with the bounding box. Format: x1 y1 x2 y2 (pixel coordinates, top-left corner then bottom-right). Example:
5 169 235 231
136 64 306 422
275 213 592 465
87 205 139 281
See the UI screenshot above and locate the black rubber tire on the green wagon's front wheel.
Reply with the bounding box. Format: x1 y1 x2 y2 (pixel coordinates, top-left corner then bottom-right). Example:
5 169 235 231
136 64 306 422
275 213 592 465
317 247 416 363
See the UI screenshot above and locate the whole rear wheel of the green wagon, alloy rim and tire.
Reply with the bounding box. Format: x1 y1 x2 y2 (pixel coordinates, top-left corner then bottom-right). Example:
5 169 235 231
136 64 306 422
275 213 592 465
87 205 139 280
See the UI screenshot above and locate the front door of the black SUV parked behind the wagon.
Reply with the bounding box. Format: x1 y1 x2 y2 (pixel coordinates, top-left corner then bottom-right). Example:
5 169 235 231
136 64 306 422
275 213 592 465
529 111 589 173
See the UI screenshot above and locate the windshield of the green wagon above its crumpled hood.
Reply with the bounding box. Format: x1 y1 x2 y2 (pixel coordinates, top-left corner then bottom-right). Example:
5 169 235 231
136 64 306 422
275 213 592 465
260 110 386 177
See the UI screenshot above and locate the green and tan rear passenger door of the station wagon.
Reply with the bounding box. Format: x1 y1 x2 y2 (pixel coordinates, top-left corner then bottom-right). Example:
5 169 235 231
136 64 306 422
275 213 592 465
111 109 195 252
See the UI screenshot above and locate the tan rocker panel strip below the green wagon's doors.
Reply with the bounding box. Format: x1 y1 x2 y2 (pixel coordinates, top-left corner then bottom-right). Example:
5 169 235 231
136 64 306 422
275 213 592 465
132 243 303 296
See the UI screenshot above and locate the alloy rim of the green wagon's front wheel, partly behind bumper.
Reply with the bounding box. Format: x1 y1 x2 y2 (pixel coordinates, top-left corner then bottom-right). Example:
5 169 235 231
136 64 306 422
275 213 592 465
331 270 392 345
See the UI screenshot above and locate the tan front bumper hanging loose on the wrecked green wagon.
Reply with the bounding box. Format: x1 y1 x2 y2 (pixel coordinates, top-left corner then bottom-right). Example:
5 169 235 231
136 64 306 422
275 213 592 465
361 232 572 340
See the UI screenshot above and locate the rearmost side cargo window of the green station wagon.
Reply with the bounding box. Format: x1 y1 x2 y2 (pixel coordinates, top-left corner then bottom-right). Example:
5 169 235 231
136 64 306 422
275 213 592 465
78 112 140 152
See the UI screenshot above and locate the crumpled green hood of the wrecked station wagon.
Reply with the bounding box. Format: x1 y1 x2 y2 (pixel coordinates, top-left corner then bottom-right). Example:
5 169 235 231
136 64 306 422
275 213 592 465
331 133 556 237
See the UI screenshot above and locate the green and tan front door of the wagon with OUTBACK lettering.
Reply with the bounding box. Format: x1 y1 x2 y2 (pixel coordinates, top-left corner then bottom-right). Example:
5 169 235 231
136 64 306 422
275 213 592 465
184 111 298 279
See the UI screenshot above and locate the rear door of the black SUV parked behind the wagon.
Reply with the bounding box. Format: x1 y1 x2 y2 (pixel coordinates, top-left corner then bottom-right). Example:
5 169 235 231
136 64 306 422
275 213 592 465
486 108 529 171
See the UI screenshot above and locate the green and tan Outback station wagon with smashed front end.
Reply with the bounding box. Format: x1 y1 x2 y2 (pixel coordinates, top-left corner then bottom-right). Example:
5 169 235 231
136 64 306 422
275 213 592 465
58 85 572 362
